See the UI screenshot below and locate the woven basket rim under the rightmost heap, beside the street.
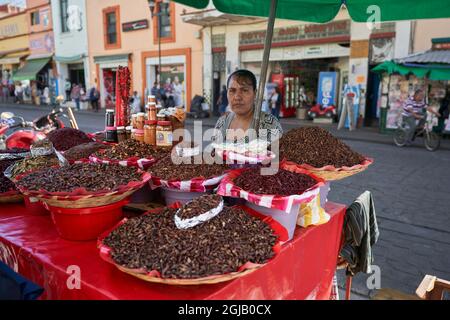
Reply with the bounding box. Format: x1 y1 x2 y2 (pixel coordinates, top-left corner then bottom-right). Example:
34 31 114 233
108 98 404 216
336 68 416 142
281 158 373 181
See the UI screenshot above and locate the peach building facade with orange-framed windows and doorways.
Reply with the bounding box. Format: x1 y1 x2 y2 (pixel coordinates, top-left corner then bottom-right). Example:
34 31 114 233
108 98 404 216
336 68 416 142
87 0 203 109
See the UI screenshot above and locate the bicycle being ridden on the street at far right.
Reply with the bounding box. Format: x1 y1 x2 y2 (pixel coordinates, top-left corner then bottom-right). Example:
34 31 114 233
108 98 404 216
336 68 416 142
394 112 441 151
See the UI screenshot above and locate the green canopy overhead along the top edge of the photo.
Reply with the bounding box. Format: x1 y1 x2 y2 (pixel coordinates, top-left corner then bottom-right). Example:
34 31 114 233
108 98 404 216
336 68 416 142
175 0 450 23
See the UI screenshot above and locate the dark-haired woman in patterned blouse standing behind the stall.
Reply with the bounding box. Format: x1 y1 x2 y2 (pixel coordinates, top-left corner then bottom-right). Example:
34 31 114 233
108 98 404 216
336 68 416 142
214 70 283 143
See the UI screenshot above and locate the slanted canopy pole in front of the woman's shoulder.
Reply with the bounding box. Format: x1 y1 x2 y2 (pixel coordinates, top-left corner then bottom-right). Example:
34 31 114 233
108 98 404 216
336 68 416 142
253 0 278 136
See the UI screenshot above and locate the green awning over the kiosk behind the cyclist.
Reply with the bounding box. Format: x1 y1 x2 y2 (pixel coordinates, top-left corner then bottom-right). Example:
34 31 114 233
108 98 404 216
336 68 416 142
372 61 450 80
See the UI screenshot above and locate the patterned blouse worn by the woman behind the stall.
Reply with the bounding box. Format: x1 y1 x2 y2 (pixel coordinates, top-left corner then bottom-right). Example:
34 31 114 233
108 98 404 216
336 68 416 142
213 112 283 143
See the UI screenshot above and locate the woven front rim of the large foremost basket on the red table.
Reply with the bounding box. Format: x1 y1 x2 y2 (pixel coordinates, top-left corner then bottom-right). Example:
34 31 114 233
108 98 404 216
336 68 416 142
116 265 261 286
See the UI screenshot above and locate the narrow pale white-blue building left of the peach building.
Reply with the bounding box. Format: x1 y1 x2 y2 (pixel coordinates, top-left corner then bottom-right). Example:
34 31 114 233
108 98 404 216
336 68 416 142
51 0 90 99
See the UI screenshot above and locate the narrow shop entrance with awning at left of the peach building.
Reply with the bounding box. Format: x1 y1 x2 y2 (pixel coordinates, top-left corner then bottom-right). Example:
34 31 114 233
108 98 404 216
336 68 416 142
94 54 131 109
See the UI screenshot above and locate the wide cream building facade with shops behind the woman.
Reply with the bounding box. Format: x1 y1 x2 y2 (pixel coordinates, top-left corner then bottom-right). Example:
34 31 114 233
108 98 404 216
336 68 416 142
183 5 450 126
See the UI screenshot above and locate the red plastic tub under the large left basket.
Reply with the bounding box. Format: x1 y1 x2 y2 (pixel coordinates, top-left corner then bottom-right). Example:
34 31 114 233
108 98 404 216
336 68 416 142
46 199 129 241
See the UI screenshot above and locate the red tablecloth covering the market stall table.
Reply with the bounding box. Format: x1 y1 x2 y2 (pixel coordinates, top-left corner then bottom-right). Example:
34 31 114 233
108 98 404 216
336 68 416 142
0 203 345 300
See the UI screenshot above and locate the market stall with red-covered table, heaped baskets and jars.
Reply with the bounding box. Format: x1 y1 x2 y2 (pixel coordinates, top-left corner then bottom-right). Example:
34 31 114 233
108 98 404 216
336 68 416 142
0 47 372 300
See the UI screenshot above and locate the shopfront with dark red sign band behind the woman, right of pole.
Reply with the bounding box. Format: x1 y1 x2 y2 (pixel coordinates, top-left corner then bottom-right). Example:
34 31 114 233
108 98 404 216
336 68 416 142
239 21 350 117
